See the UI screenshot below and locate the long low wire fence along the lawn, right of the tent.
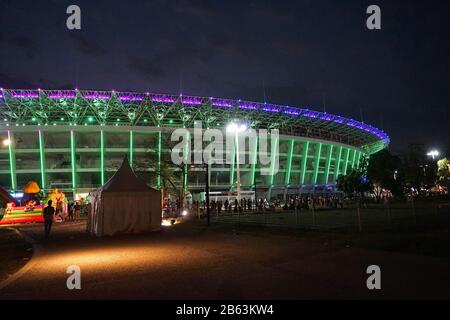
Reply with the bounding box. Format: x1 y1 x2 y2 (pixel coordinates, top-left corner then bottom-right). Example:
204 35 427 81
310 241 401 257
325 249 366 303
200 201 450 232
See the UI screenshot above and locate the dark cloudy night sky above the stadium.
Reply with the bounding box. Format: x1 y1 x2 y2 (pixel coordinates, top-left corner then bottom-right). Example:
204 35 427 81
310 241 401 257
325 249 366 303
0 0 450 152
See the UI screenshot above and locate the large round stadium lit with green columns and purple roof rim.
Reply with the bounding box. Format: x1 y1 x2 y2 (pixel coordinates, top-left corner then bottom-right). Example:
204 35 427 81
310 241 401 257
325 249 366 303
0 89 389 197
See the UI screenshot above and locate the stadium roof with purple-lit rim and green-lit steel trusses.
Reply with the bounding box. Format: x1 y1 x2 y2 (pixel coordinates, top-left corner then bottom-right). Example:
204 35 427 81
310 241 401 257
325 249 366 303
0 89 389 154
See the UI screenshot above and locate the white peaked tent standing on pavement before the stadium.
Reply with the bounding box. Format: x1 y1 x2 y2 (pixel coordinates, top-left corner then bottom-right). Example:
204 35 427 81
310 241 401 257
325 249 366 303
87 158 161 237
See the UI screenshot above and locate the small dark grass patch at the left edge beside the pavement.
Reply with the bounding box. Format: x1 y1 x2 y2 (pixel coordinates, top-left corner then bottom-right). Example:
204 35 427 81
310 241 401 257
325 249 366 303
0 227 33 281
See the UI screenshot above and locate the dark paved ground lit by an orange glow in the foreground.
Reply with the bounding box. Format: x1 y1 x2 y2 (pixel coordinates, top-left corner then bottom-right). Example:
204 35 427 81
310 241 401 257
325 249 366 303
0 222 450 299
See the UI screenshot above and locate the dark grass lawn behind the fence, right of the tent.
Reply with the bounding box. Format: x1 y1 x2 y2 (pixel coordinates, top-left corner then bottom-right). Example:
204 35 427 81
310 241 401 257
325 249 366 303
197 205 450 257
